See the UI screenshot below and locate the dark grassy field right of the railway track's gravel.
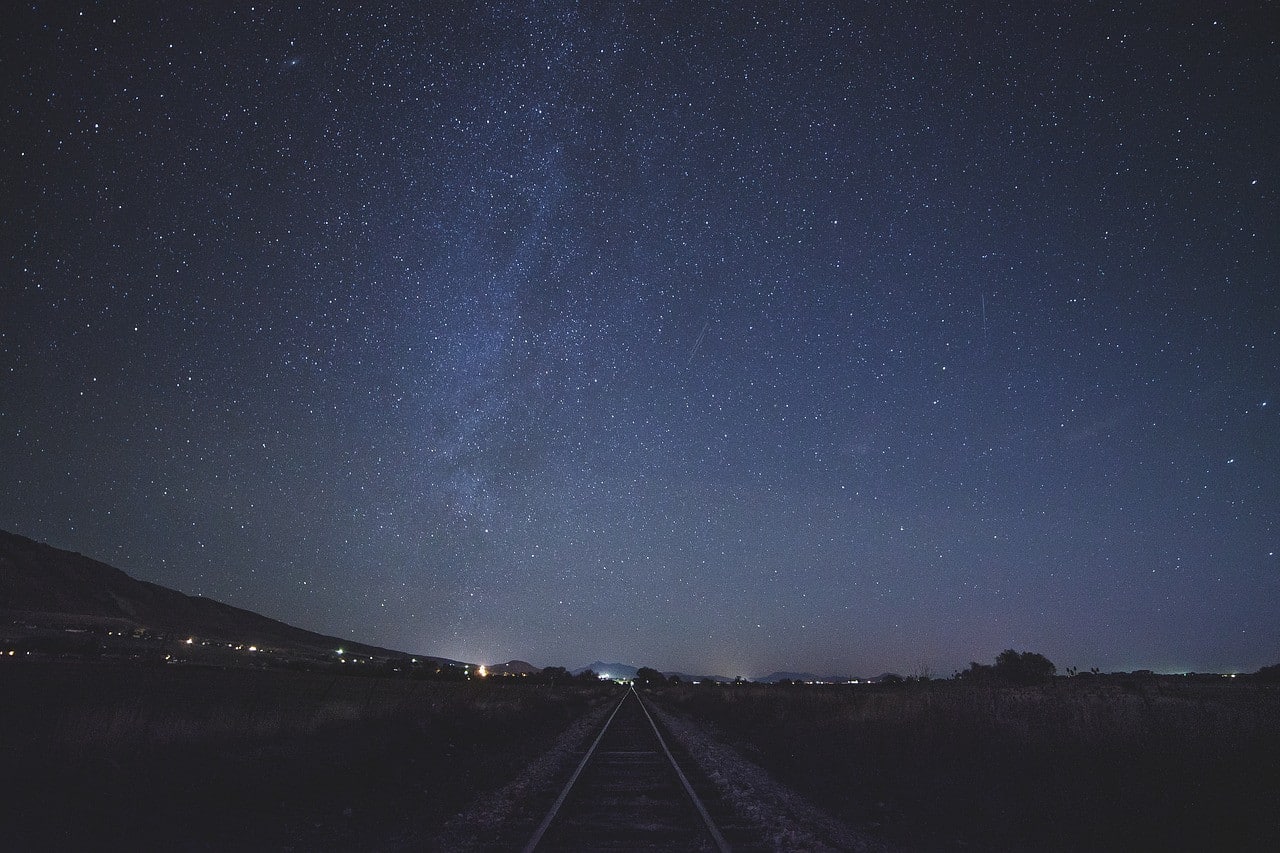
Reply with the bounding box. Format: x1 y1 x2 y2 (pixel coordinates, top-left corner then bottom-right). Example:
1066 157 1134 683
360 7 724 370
655 678 1280 850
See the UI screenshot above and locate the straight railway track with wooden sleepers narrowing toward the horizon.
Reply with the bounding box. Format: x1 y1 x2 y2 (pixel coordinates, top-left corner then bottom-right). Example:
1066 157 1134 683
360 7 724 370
525 688 730 853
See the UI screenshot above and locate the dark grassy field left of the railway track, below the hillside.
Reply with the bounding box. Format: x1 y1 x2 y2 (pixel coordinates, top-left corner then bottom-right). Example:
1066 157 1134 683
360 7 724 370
0 662 612 850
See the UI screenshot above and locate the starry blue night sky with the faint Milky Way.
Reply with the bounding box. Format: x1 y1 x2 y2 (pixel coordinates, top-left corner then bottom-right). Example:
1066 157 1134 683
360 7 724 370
0 0 1280 676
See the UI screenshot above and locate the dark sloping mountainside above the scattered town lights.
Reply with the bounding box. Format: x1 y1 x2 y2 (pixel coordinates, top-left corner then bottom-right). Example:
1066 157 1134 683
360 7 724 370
0 530 454 663
